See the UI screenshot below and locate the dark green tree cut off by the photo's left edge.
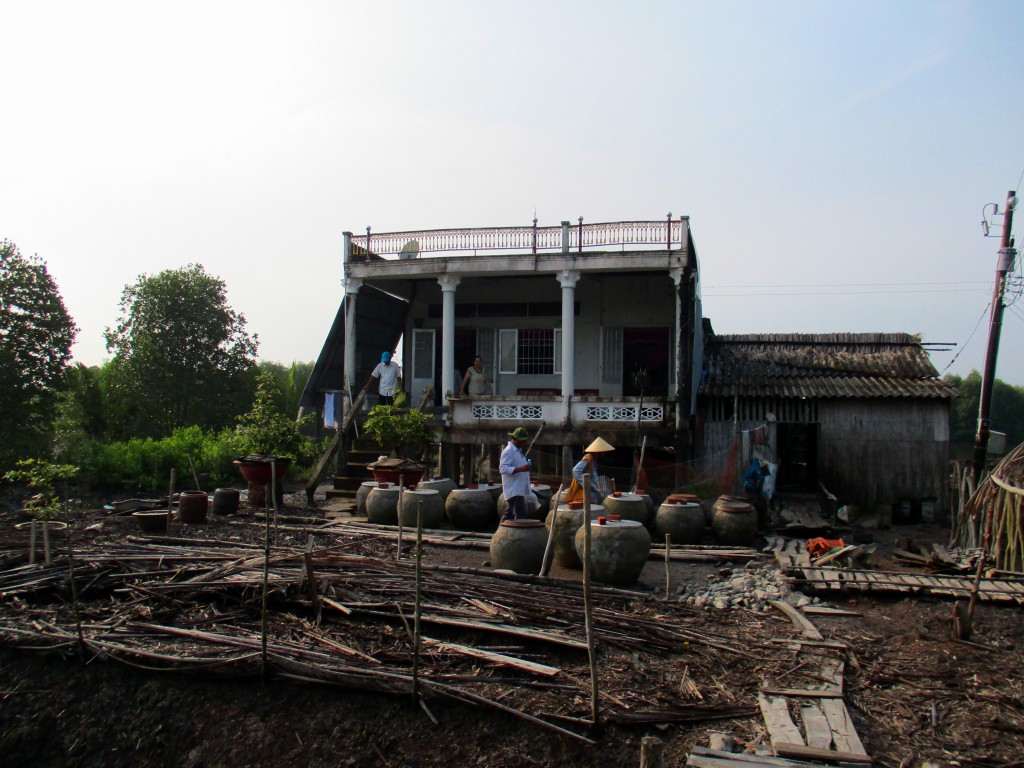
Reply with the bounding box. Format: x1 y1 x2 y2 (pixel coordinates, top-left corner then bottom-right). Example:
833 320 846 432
0 240 78 469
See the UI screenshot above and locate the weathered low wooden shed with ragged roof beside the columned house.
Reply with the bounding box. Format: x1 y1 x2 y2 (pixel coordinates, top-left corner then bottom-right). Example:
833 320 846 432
698 327 961 519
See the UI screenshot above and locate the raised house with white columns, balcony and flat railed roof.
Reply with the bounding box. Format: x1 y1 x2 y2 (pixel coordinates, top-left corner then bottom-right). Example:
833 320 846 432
303 215 702 483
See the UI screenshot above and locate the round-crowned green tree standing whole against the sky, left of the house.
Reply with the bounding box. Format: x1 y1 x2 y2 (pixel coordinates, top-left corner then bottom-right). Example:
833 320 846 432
102 264 257 437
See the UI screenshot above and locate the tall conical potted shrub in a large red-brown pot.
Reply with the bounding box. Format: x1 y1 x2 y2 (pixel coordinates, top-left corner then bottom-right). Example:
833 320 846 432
234 371 310 506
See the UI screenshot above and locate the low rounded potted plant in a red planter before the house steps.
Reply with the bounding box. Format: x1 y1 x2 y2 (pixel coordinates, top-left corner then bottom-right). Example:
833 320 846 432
362 406 434 485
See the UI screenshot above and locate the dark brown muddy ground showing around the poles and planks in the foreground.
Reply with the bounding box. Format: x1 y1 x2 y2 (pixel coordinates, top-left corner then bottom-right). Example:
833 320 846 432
0 495 1024 768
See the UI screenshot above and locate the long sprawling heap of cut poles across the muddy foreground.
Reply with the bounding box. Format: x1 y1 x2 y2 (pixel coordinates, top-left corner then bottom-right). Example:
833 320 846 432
0 527 763 740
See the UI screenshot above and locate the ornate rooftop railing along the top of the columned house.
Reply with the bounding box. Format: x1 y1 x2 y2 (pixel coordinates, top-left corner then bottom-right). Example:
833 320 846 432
346 214 688 260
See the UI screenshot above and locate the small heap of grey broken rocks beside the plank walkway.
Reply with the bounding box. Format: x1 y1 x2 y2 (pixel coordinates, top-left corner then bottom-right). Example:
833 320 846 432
679 560 818 613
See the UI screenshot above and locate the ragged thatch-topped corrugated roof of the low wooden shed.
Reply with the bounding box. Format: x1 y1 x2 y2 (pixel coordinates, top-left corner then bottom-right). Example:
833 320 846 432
700 334 959 398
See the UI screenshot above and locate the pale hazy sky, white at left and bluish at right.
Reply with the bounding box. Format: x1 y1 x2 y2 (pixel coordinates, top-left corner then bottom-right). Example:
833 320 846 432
0 0 1024 386
